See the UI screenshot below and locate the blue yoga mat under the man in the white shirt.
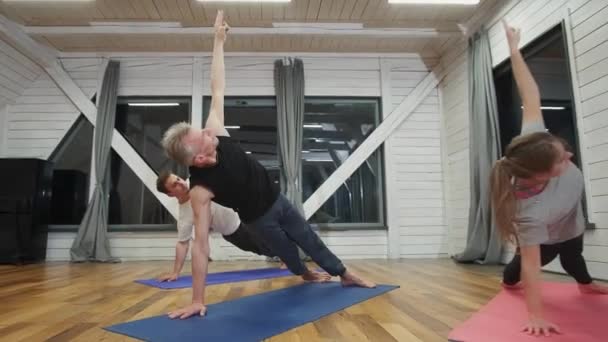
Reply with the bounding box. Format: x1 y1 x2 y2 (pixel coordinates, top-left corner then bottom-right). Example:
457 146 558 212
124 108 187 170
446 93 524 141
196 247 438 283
135 268 293 290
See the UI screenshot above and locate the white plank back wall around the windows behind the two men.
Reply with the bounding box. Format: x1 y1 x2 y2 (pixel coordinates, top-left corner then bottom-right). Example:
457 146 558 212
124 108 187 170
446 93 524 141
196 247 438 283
7 56 447 260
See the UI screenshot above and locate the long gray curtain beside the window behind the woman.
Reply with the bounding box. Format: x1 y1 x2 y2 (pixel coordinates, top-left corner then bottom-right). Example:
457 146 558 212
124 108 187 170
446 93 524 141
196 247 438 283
454 28 502 264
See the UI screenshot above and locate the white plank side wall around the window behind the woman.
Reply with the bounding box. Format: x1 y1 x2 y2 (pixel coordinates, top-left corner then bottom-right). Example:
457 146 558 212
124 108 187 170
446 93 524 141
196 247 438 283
442 0 608 279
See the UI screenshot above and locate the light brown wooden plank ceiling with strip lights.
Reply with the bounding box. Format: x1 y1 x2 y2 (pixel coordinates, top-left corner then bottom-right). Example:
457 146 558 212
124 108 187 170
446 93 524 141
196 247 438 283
0 0 483 55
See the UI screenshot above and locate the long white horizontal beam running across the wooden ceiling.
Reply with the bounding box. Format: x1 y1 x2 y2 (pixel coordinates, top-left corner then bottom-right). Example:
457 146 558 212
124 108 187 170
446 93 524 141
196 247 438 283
24 23 462 39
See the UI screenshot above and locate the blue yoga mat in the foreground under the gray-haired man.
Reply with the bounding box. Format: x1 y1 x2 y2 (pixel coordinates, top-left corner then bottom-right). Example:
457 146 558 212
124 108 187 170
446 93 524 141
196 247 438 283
105 282 398 342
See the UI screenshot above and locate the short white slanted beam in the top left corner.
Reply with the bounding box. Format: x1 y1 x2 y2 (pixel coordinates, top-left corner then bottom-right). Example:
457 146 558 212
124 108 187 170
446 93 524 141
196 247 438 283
0 14 58 68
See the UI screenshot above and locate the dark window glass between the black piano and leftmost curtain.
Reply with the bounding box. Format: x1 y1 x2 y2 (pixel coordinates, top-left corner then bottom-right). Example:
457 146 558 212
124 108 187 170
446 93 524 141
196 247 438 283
49 115 93 225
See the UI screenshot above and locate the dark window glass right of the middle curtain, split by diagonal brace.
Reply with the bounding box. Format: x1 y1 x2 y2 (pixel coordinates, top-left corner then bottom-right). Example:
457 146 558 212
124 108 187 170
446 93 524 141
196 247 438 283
302 98 383 224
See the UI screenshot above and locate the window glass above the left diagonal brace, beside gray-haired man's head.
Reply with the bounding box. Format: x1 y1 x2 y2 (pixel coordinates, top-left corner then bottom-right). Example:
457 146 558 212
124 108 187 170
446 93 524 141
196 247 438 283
115 98 190 176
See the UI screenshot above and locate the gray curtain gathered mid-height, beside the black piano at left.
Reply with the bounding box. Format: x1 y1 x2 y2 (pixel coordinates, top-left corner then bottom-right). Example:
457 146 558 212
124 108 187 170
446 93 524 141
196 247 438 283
70 61 120 262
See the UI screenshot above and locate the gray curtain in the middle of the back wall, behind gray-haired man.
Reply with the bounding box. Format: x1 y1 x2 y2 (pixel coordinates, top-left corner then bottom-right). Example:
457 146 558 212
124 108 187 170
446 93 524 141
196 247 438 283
274 58 304 213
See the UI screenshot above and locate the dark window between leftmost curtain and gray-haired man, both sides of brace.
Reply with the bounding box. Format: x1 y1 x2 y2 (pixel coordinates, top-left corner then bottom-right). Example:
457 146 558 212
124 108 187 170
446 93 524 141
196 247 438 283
109 97 190 226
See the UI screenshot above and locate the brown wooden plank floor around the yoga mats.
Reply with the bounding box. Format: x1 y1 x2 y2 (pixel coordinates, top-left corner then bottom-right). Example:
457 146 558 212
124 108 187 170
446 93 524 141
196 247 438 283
0 259 567 342
